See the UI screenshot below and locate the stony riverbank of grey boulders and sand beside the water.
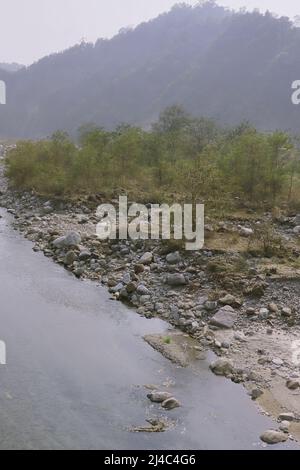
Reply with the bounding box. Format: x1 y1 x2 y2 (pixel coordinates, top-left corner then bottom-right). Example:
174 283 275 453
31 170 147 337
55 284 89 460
0 163 300 443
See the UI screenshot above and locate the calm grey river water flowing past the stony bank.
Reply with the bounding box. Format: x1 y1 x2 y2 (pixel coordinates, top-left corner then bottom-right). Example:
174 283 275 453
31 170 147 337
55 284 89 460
0 210 294 450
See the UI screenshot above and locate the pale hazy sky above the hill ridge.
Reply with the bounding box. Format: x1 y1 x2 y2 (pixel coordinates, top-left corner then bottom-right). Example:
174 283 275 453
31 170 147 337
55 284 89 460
0 0 300 64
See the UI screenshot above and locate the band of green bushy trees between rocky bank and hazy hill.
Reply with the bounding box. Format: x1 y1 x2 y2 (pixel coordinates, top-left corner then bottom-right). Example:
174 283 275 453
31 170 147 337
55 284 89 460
7 106 300 210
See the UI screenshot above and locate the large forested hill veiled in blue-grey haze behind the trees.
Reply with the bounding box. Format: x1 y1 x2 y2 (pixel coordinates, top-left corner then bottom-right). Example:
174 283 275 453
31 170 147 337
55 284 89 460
0 2 300 137
